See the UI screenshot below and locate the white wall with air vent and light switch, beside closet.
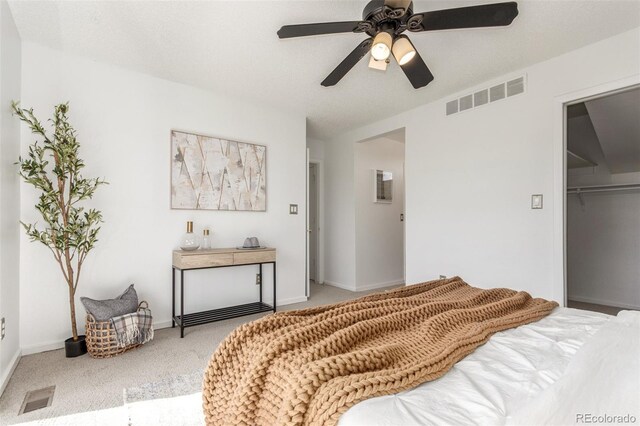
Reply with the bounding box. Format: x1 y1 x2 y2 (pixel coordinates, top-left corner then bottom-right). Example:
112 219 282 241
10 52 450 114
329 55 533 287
325 29 640 301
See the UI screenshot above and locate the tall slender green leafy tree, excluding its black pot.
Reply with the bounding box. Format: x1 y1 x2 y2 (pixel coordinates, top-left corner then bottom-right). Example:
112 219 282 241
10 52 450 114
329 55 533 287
11 102 107 341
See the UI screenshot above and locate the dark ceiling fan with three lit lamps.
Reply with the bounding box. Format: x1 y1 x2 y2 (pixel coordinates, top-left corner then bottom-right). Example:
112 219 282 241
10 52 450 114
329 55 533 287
278 0 518 89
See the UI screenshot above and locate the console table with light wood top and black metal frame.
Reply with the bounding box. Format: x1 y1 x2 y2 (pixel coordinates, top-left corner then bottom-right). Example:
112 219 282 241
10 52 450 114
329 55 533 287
171 248 276 338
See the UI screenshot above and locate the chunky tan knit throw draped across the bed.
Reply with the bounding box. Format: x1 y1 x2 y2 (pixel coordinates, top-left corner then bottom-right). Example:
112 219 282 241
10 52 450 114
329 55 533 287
203 277 557 426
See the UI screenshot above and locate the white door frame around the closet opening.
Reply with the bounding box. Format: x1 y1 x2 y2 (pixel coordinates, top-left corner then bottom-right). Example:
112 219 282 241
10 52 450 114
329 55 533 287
551 74 640 307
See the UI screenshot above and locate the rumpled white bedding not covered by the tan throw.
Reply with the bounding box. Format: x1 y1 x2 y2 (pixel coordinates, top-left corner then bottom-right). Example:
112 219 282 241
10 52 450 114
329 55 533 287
338 308 640 426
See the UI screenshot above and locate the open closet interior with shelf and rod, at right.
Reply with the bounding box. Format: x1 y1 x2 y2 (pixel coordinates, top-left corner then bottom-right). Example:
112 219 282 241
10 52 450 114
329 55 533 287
565 86 640 315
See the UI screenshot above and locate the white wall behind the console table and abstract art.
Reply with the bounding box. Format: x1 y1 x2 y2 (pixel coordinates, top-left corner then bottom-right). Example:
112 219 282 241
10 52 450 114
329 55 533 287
20 43 306 353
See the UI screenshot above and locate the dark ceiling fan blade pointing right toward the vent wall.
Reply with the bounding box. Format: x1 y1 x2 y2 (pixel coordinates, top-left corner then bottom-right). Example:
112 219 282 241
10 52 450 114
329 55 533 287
407 2 518 31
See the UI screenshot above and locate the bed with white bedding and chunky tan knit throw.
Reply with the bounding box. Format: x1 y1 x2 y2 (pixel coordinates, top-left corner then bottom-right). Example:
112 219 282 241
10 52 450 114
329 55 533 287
203 277 640 426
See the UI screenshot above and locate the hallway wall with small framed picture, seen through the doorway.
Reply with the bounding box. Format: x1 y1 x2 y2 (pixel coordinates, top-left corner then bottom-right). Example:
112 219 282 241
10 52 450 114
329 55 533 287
353 138 404 291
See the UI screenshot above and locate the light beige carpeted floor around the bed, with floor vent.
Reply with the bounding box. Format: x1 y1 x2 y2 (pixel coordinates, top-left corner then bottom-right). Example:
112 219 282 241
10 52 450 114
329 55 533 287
0 283 396 425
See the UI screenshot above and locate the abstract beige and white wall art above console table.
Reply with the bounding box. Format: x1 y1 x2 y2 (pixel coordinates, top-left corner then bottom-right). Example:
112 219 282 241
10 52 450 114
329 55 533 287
171 130 267 211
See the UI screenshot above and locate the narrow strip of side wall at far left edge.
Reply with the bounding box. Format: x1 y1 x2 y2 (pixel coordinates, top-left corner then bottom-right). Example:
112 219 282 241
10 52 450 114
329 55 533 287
0 0 21 394
